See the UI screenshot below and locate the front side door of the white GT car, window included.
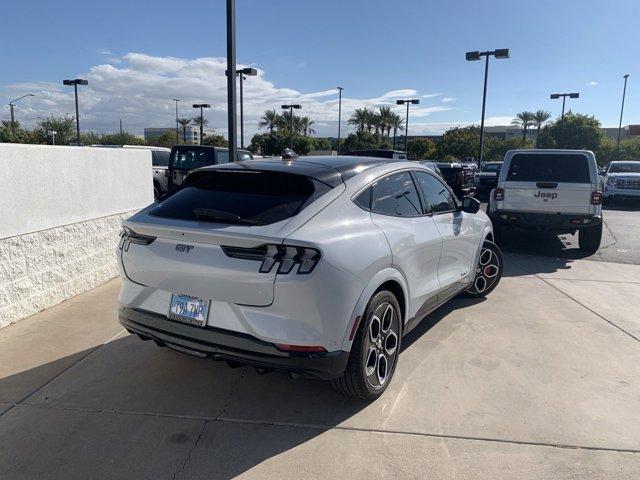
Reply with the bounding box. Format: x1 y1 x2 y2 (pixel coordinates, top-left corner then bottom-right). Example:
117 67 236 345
414 171 478 297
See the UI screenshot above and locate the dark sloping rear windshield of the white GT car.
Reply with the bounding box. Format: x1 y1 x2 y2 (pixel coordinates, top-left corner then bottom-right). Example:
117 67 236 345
149 170 331 225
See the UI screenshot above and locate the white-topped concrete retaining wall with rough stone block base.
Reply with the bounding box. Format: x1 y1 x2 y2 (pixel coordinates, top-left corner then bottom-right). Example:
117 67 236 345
0 144 153 328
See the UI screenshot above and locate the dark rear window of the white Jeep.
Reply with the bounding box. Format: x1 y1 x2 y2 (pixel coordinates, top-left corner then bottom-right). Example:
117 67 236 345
507 153 591 183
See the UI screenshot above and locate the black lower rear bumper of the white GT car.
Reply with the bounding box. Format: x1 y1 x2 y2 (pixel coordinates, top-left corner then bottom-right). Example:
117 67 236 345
118 307 349 380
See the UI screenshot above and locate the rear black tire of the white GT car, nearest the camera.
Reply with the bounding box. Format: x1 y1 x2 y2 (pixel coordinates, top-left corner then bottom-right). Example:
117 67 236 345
332 290 402 400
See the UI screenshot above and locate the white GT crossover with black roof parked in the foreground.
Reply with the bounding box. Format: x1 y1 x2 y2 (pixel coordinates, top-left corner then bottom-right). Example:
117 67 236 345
118 156 503 399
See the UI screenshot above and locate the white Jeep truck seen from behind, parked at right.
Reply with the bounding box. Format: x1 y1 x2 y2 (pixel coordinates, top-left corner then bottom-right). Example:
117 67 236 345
487 149 602 253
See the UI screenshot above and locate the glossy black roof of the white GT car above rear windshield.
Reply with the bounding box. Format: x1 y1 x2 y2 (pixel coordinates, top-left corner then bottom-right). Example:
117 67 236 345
197 155 406 187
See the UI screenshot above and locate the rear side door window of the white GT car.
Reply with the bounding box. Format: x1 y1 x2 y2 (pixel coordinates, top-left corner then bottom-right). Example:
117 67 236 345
371 172 422 217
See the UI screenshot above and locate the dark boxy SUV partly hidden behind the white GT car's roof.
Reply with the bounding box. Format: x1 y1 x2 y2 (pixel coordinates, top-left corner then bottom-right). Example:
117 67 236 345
168 145 253 192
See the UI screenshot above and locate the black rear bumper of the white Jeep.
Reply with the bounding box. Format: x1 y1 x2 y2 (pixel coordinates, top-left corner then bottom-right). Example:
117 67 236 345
491 210 602 231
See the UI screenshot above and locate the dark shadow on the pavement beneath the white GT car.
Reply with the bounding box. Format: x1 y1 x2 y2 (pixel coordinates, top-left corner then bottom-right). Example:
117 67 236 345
0 298 483 479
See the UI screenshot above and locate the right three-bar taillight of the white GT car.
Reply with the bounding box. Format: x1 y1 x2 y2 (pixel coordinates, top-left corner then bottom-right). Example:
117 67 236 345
222 244 321 275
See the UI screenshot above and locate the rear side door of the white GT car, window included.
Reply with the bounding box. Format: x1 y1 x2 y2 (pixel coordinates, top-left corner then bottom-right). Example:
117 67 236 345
363 171 442 318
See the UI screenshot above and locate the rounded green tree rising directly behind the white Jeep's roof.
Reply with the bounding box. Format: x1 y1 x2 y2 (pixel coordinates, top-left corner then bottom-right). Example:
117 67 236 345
538 112 604 152
